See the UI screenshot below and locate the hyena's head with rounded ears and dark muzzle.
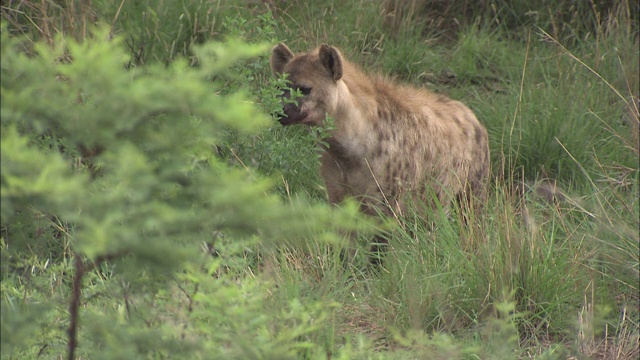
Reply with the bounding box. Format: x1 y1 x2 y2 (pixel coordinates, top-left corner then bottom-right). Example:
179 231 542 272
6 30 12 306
271 44 342 126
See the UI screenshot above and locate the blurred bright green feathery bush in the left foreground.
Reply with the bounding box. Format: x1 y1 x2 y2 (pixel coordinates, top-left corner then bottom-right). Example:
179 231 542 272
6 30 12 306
0 24 368 358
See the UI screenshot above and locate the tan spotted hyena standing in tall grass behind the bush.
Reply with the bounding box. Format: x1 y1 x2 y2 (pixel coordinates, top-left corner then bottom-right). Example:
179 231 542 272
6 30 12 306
271 44 489 222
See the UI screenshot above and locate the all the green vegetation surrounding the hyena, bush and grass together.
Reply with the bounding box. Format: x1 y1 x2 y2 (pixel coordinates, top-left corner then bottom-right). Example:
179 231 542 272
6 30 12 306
0 0 640 359
